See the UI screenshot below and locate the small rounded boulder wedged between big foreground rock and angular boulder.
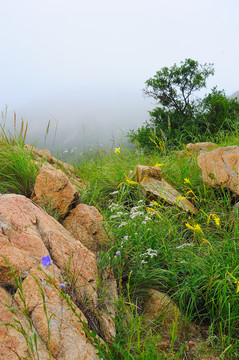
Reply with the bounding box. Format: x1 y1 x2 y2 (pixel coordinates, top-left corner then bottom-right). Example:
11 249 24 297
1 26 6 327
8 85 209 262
62 204 106 252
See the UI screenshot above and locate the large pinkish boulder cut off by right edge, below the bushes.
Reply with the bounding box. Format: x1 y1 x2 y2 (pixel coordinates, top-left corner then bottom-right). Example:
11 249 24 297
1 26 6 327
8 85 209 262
197 146 239 195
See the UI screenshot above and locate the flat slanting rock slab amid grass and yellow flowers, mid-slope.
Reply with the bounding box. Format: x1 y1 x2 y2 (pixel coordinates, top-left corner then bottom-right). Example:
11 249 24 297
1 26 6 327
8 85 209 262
135 165 197 214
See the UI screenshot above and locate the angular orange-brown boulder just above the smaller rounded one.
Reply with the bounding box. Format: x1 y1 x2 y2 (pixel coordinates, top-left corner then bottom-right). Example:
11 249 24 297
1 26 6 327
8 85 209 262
31 164 79 218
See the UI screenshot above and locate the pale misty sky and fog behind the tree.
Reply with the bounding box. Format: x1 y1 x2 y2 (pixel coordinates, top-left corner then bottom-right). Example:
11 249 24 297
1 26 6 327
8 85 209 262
0 0 239 148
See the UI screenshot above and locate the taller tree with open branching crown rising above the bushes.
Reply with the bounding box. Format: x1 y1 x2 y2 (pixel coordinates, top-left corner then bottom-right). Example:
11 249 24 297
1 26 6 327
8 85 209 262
144 59 214 132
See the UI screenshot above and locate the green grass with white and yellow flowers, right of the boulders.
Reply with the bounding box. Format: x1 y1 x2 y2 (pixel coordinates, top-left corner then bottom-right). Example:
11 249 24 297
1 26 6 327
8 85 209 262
75 137 239 359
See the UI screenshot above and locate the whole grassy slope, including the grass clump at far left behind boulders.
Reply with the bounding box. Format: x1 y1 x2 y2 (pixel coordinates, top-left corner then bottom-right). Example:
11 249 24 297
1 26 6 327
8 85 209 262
0 131 239 360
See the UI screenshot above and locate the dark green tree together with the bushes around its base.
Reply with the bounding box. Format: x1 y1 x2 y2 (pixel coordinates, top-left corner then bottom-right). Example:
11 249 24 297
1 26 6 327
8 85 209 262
128 59 239 148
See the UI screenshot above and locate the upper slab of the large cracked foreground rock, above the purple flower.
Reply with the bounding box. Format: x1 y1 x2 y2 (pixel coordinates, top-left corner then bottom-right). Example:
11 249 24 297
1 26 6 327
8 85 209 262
0 194 98 303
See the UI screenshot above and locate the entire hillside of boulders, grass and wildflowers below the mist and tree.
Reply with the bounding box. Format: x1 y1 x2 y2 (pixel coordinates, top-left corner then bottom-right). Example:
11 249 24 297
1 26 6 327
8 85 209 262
0 127 239 360
